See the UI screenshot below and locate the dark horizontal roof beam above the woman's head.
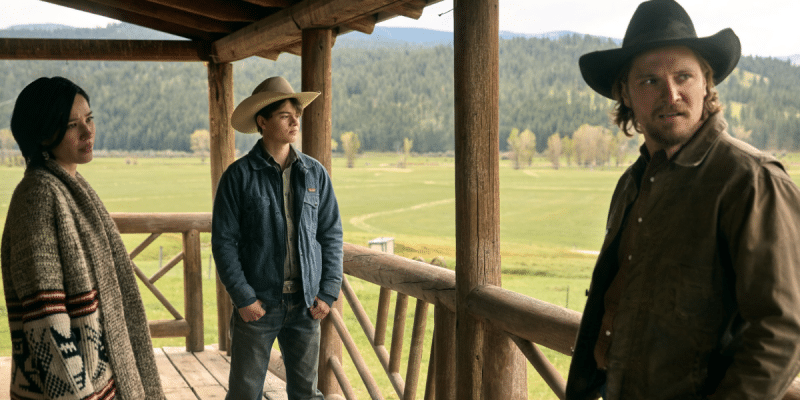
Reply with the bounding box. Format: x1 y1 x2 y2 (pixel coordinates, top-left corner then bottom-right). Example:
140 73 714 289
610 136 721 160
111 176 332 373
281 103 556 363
0 38 211 61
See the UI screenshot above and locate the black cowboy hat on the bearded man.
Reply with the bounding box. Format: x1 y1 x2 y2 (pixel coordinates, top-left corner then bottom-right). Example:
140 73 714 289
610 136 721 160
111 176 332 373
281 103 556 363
578 0 742 98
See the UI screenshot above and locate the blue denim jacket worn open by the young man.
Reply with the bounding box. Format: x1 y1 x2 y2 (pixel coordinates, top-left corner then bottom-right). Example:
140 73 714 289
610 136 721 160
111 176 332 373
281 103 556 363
211 140 342 308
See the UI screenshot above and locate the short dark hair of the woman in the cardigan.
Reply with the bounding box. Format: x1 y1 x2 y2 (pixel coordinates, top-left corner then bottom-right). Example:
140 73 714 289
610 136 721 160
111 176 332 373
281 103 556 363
11 76 89 165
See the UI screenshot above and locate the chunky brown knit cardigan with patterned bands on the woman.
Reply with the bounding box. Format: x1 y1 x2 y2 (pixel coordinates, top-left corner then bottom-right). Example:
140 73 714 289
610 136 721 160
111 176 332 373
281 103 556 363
0 160 165 400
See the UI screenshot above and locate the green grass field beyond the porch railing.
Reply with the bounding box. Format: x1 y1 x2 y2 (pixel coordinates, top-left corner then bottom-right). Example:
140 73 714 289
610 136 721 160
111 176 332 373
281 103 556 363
0 154 800 399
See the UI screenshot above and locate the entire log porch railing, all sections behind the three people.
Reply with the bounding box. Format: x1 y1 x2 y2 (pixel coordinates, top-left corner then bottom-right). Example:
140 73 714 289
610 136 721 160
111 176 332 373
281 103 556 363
112 213 800 400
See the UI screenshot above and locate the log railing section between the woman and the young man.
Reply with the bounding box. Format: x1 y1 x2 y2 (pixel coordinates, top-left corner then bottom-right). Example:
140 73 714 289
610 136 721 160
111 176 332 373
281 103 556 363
111 213 211 352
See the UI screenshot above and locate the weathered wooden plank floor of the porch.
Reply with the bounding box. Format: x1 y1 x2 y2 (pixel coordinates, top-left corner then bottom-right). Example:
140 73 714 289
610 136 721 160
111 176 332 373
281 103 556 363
0 345 286 400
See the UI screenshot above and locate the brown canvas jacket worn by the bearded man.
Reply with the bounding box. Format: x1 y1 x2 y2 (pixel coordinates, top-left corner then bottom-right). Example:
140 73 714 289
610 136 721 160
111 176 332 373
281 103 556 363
567 114 800 399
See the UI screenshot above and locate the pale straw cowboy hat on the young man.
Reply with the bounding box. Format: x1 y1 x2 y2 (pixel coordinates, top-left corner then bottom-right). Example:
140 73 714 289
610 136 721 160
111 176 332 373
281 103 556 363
231 76 319 133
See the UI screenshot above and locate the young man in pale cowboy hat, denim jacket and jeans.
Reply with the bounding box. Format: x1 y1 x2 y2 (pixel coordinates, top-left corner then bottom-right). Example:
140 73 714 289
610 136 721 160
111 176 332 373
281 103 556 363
211 77 342 400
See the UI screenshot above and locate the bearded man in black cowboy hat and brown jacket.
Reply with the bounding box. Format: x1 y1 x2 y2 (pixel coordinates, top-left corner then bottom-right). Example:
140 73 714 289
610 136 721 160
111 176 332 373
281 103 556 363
567 0 800 400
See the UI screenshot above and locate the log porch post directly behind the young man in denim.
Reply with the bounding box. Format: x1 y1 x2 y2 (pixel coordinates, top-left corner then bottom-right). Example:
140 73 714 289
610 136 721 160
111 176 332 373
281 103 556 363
301 29 343 396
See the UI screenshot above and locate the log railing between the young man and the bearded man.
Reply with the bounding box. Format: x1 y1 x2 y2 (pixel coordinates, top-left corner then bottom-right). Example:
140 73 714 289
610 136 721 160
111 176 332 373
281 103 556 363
338 243 580 400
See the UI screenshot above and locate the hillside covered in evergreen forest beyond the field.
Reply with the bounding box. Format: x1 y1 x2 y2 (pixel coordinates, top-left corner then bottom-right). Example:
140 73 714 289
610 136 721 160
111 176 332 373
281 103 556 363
0 25 800 152
